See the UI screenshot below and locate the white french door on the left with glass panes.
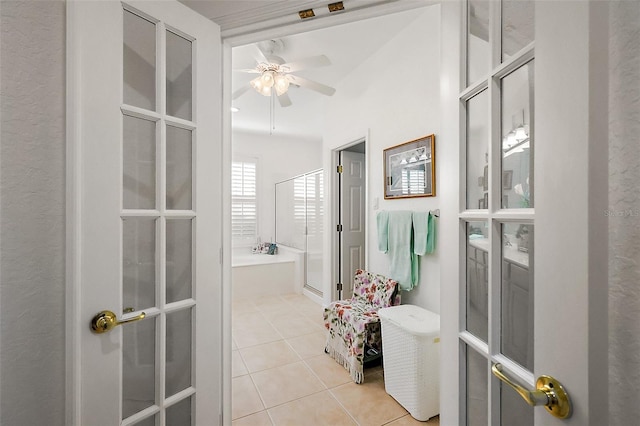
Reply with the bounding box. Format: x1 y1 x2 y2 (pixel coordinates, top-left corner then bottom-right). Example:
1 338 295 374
68 1 222 426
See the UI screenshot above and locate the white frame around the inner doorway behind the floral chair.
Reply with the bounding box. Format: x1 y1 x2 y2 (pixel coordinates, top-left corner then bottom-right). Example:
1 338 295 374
327 138 370 300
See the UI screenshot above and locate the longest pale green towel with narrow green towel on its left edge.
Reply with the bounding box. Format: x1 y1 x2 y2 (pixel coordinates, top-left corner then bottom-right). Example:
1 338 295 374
377 211 419 291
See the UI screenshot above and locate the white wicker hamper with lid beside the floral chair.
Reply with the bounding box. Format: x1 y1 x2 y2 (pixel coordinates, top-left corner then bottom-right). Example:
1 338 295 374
378 305 440 421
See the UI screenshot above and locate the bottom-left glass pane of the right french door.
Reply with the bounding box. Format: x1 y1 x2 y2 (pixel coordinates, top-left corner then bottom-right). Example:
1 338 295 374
466 346 489 426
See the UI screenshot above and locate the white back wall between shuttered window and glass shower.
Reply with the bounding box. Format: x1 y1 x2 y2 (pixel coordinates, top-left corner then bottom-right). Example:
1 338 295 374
232 131 322 248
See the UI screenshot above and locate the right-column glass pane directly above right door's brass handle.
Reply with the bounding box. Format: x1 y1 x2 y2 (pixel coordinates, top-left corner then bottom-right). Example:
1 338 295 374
501 223 533 370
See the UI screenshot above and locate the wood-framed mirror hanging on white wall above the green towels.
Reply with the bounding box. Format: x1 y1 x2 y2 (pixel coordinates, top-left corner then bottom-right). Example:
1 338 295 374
383 135 436 199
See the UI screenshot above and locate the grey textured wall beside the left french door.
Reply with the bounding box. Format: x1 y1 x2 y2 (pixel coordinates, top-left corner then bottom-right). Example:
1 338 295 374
0 0 65 426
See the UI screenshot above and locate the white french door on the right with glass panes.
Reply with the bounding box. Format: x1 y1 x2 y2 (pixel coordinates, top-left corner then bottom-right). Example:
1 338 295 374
440 0 607 426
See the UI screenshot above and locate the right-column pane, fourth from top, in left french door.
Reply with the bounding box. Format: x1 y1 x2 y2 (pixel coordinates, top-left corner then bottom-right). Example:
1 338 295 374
165 308 192 397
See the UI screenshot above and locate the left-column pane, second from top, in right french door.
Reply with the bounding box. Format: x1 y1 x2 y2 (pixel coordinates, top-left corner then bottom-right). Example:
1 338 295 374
467 90 489 209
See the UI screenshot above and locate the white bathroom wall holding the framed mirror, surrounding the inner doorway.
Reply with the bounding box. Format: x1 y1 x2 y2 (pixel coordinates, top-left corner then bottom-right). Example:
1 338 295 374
323 6 443 312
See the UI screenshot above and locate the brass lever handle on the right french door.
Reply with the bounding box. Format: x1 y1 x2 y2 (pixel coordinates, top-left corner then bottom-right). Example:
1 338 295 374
491 364 571 419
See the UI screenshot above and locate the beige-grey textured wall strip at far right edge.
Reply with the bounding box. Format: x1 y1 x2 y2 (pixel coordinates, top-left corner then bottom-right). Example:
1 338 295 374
607 1 640 426
